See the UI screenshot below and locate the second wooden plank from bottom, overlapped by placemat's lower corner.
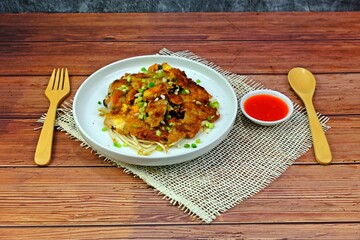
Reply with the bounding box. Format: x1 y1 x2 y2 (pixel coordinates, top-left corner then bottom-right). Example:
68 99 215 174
0 164 360 226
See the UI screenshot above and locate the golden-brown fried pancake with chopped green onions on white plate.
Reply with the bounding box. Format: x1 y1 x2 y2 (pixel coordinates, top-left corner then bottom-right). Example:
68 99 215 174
103 63 220 146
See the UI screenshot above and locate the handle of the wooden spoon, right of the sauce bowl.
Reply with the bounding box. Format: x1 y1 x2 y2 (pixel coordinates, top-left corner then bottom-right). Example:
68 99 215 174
304 100 332 164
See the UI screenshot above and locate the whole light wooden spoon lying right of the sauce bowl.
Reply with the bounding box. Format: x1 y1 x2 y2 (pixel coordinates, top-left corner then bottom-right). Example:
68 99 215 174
288 67 332 164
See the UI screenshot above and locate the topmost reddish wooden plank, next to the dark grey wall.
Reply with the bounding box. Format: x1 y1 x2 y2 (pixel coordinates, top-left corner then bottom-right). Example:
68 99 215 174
0 12 360 42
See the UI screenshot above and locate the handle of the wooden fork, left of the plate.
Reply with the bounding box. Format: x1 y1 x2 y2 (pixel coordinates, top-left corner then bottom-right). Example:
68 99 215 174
34 102 57 166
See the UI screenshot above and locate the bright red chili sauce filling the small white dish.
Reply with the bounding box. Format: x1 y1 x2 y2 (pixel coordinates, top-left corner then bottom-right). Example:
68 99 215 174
244 94 289 121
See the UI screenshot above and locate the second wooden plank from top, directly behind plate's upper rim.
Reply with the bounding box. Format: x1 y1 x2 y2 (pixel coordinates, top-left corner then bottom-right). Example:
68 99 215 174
0 40 360 75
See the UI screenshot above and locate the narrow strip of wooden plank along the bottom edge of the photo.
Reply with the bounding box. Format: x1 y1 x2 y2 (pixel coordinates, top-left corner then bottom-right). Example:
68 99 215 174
0 223 360 240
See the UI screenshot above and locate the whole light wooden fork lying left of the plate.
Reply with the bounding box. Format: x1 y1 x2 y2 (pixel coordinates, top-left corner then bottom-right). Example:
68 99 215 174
34 68 70 166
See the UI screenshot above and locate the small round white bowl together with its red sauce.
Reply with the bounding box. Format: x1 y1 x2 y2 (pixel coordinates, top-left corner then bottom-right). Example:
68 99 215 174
240 89 294 126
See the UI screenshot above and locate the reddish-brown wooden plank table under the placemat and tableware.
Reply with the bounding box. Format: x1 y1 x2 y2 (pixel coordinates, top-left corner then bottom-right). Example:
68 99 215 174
0 12 360 239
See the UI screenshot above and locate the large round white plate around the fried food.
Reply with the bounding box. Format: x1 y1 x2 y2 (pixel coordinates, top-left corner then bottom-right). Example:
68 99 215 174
73 55 237 166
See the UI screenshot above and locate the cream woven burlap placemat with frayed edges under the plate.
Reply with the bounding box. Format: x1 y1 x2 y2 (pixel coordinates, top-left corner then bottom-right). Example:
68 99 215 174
52 49 329 223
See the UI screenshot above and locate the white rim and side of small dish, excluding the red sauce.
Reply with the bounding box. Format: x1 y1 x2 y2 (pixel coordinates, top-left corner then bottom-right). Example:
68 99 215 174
240 89 294 126
